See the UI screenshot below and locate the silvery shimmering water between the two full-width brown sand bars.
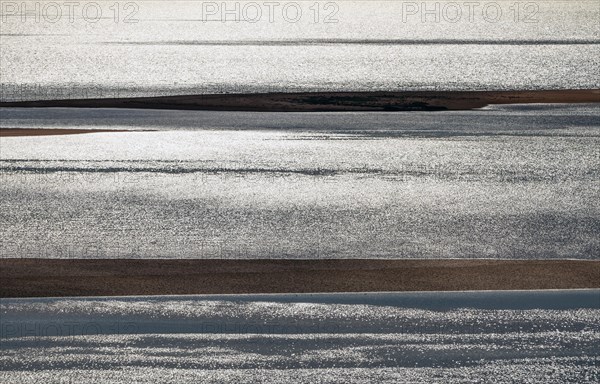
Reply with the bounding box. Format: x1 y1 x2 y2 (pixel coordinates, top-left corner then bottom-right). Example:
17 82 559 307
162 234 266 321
0 105 600 259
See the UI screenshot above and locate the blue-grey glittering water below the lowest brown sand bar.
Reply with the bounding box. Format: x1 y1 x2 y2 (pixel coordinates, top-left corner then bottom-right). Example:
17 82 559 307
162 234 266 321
0 290 600 383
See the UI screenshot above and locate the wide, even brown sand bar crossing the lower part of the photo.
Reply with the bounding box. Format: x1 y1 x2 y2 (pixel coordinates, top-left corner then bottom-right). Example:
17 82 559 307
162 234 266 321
0 259 600 297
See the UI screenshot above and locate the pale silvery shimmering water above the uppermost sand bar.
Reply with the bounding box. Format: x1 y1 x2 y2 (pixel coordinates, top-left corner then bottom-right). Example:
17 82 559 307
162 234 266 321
0 0 600 100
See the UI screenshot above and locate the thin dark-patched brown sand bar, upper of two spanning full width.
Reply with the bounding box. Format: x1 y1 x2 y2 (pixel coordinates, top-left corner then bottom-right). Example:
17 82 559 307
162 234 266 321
0 89 600 112
